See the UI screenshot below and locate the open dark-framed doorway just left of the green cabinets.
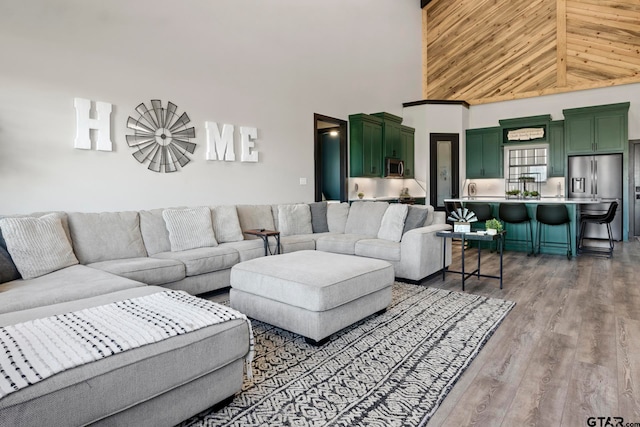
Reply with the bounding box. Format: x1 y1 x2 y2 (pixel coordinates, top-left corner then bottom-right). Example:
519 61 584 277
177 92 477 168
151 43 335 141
313 114 347 202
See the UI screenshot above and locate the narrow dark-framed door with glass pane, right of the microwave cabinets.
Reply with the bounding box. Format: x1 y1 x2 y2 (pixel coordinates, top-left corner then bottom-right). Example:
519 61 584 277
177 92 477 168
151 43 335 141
429 133 460 211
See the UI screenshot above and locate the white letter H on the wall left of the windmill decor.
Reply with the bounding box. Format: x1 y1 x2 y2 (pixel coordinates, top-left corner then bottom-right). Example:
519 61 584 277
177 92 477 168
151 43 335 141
73 98 113 151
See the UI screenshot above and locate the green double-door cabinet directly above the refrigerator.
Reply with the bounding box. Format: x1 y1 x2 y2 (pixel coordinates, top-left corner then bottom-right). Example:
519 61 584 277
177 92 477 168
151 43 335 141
563 102 630 155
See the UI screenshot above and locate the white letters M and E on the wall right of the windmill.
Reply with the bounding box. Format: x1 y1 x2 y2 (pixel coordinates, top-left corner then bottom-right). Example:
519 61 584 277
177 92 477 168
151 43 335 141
205 122 259 162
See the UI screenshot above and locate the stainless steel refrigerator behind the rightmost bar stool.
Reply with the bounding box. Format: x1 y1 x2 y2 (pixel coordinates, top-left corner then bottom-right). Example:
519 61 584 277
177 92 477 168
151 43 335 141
567 154 622 240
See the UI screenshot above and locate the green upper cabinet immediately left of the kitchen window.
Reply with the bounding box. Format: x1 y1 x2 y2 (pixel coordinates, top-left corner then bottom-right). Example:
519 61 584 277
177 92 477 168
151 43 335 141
466 127 502 178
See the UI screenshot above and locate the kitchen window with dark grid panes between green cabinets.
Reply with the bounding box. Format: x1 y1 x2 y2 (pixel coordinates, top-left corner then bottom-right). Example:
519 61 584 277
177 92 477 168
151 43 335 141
504 144 549 182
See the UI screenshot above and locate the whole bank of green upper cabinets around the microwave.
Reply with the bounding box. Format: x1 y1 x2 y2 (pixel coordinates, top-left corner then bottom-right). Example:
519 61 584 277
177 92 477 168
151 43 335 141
349 113 415 178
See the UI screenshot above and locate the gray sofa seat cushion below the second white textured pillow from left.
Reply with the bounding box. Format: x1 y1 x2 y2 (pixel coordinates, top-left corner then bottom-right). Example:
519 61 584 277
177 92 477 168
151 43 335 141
153 246 240 276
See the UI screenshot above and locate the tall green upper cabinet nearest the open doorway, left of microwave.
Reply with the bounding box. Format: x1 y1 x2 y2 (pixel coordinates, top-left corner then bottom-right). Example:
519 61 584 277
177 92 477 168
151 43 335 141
349 114 384 177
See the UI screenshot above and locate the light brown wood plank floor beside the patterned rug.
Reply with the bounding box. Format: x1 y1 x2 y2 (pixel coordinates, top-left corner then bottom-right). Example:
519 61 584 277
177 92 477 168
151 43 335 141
422 239 640 426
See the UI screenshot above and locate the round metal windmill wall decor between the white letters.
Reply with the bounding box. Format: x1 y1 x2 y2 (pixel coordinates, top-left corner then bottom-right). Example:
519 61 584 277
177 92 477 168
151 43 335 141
127 99 196 172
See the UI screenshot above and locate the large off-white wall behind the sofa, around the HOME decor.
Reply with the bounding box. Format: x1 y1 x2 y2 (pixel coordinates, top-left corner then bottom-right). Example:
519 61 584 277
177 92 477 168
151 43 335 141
0 0 421 213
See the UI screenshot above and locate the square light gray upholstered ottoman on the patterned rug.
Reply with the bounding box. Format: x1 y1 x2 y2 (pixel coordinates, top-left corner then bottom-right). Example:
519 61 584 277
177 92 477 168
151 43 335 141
229 251 394 345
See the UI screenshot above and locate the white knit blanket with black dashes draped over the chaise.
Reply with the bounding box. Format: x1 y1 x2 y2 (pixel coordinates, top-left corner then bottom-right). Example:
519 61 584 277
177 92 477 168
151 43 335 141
0 291 253 398
